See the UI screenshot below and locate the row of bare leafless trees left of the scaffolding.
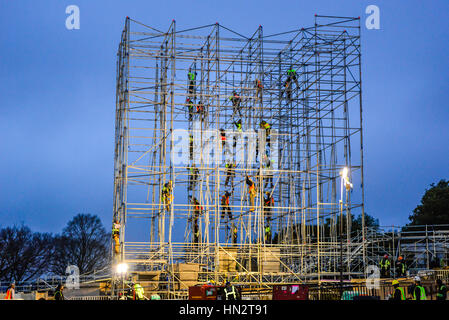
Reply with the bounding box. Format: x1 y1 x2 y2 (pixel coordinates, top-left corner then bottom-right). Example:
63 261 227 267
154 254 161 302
0 214 110 282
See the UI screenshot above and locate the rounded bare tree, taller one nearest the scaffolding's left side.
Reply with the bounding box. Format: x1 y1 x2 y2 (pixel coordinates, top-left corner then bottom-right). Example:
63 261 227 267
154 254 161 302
52 214 110 274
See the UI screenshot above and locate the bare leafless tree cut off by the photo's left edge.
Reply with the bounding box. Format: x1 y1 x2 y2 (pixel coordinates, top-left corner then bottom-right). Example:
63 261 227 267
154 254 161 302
0 226 54 282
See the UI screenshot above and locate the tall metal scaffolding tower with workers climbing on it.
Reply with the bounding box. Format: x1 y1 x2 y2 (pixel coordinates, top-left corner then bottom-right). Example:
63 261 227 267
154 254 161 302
113 15 367 297
